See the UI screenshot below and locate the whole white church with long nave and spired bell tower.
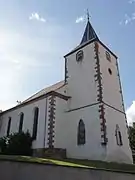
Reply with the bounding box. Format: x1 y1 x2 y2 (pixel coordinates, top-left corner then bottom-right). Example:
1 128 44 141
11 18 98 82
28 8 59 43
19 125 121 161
0 18 132 163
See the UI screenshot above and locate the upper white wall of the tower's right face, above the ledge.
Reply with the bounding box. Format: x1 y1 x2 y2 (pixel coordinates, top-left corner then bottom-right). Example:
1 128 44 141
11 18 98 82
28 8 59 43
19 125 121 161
98 43 123 111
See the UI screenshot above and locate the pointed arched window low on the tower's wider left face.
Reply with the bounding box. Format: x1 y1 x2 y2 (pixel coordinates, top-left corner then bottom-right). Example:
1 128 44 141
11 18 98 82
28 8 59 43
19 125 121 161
77 119 86 145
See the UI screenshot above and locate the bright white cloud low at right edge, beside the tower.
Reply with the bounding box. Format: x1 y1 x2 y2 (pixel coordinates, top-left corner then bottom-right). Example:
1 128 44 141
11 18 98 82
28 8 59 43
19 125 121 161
126 101 135 125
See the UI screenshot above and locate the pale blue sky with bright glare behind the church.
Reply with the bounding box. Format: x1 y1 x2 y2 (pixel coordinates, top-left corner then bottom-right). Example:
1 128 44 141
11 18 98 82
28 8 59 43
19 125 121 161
0 0 135 124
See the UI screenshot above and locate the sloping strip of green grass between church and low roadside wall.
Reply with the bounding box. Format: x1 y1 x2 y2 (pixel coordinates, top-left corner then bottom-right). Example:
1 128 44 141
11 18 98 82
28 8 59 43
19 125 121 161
0 155 135 173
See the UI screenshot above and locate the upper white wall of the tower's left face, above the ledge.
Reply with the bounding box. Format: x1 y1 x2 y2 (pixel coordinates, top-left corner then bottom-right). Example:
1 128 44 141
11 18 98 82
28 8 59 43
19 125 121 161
66 43 97 109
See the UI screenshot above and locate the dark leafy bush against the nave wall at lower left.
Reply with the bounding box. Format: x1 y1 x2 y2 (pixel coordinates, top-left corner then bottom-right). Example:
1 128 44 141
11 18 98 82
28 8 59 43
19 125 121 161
0 132 32 156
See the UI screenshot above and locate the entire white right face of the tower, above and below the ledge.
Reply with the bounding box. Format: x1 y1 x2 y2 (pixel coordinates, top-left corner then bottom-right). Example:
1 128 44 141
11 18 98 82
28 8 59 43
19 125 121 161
99 44 132 162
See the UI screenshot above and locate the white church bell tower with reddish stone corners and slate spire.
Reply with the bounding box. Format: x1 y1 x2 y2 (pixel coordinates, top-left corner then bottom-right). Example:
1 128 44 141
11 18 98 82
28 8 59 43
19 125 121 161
65 17 132 163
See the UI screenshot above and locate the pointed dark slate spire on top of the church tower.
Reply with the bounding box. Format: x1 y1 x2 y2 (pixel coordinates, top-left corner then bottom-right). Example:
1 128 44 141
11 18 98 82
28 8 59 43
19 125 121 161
80 19 99 45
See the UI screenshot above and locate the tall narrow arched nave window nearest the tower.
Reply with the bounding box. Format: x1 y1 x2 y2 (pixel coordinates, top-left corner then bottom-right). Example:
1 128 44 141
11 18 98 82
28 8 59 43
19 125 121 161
32 107 39 140
